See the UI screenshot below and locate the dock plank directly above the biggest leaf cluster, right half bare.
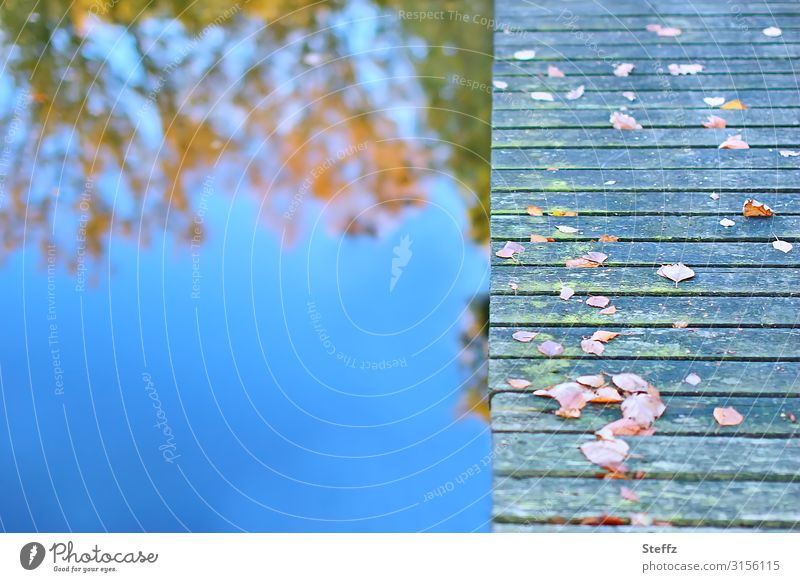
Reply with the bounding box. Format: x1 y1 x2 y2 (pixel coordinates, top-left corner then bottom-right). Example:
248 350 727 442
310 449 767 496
489 328 800 360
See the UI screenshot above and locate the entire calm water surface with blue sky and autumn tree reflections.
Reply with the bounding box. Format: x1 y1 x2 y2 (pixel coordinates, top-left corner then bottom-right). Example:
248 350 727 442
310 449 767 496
0 0 491 531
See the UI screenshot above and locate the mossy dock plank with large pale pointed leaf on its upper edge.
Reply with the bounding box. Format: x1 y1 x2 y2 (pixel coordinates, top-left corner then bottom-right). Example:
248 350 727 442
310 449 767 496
491 268 800 296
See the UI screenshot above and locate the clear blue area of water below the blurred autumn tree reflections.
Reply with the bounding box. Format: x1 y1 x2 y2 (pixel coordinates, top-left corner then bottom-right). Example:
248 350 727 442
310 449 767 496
0 3 490 532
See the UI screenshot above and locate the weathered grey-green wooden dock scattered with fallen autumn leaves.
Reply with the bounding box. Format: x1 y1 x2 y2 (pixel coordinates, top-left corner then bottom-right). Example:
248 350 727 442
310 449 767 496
489 0 800 531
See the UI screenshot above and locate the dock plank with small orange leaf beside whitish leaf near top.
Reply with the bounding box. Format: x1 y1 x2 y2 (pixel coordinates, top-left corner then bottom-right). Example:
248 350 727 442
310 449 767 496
492 90 800 109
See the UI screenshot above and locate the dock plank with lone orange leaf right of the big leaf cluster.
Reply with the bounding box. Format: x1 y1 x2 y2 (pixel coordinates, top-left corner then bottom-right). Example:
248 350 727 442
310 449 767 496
492 392 800 438
